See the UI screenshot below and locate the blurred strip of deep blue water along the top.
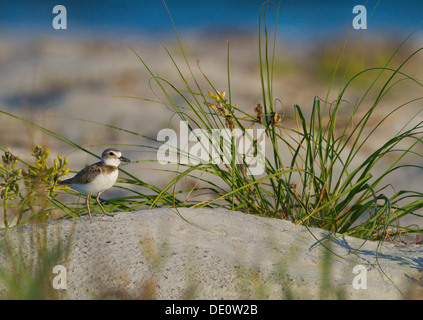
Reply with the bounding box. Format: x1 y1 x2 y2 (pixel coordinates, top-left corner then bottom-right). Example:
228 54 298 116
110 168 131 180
0 0 423 40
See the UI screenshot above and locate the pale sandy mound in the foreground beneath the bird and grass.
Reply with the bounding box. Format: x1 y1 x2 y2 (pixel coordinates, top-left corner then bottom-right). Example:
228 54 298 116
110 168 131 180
0 209 423 300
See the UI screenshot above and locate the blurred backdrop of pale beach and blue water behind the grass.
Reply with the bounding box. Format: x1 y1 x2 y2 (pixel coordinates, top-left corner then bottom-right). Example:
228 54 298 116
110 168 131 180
0 0 423 225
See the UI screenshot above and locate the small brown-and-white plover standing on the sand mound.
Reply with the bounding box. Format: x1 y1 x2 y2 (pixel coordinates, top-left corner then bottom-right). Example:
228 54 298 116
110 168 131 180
59 148 130 218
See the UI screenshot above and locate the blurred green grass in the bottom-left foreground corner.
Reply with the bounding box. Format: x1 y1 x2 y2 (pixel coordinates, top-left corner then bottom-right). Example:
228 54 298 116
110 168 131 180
0 223 74 300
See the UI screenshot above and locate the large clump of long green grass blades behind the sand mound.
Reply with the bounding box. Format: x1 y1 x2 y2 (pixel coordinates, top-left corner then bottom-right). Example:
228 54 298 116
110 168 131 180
125 2 423 240
